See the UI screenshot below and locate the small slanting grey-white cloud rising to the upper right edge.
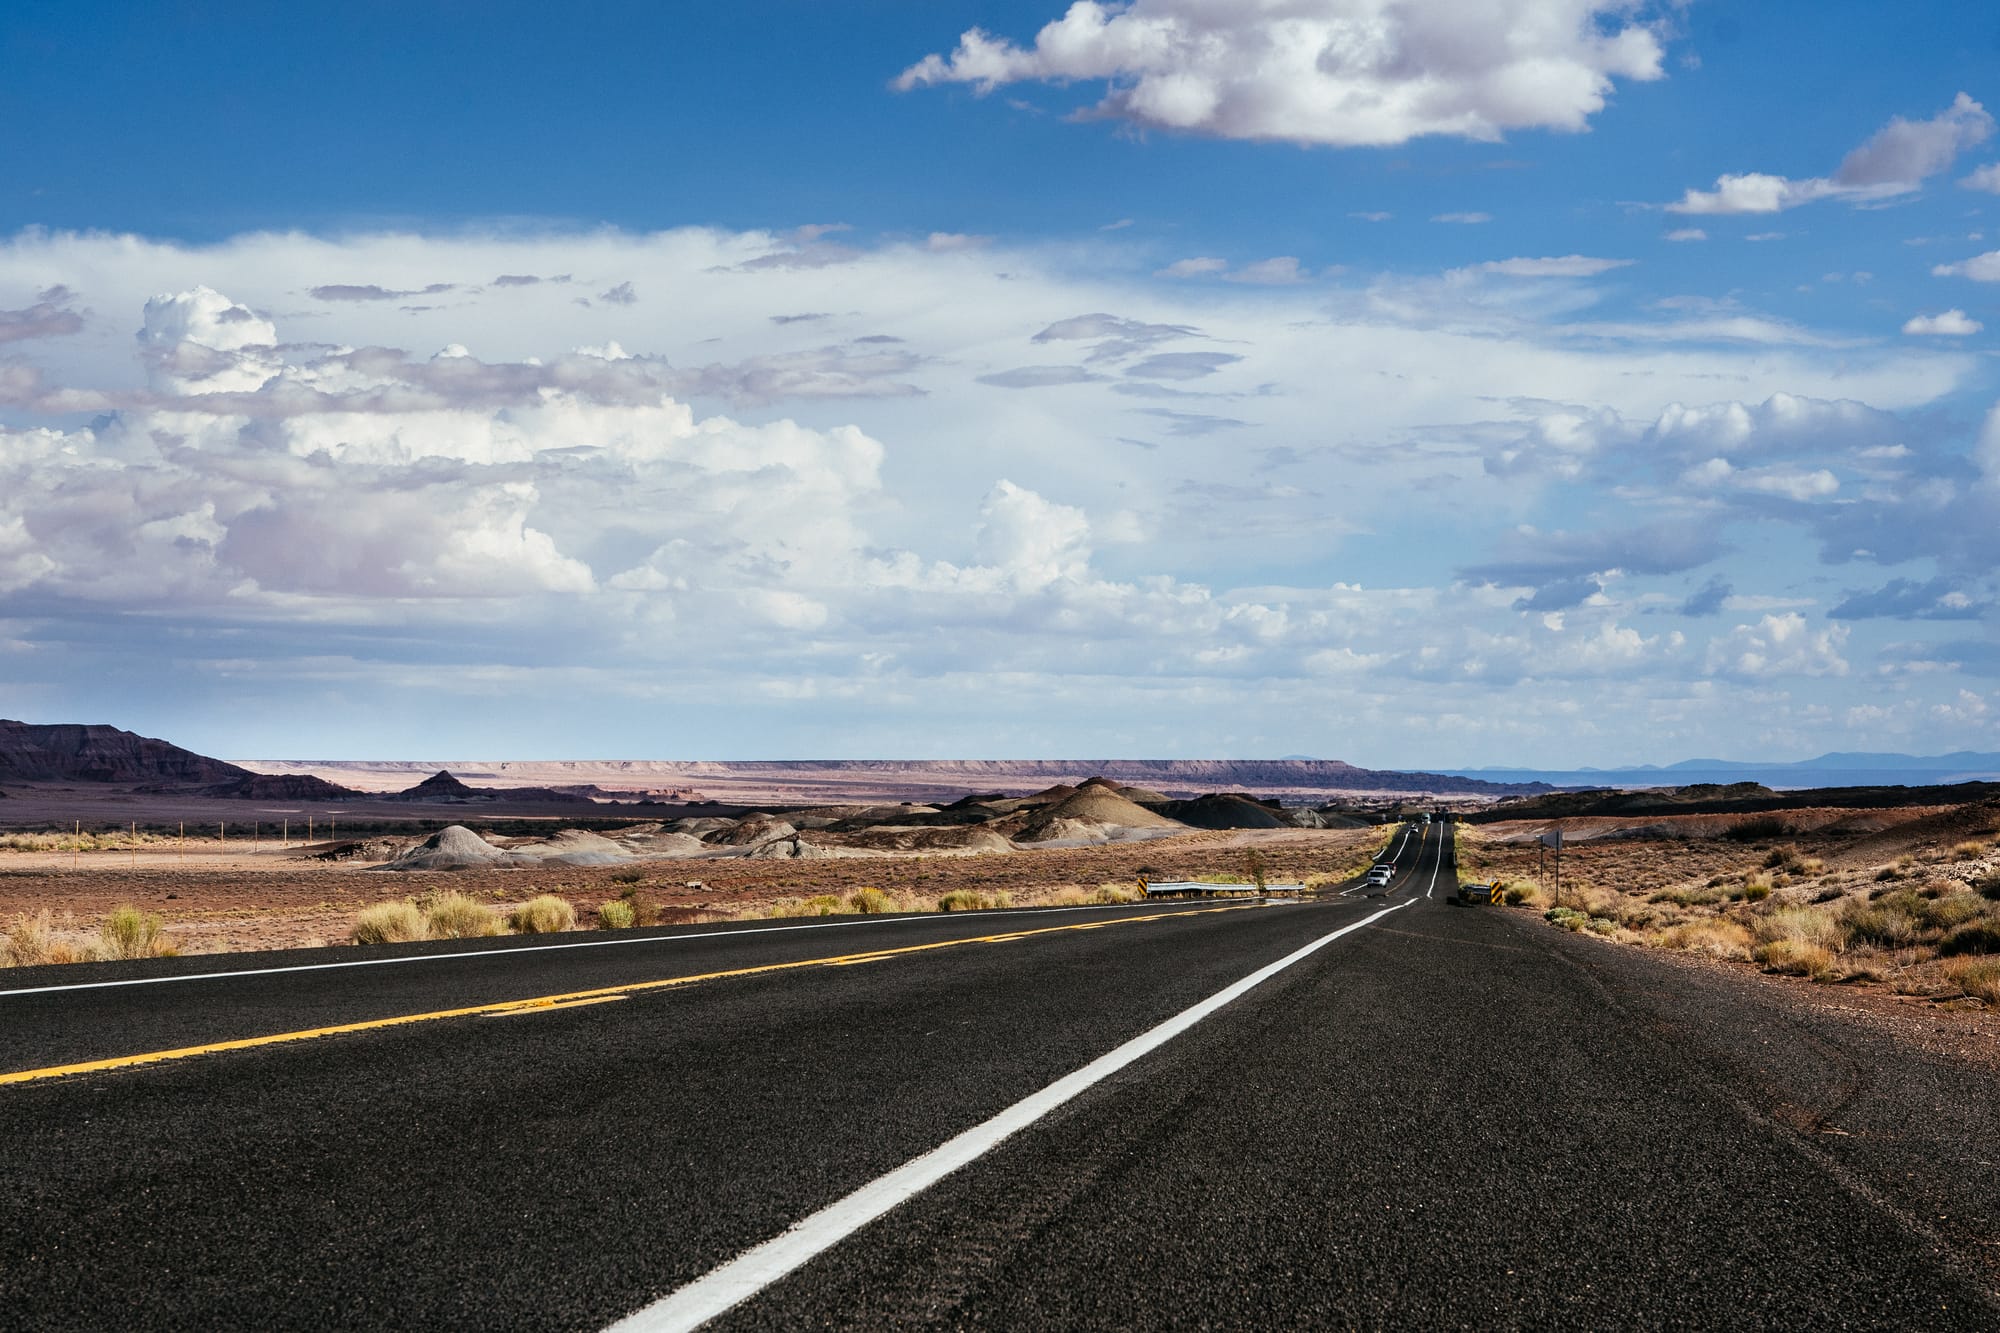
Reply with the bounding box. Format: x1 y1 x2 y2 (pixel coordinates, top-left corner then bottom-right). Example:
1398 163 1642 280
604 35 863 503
1666 92 1994 214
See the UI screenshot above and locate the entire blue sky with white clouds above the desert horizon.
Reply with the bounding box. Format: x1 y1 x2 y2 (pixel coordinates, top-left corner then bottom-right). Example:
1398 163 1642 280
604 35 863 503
0 0 2000 769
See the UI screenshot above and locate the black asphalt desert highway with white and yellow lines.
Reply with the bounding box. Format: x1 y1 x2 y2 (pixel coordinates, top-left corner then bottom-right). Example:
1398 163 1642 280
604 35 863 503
0 823 2000 1329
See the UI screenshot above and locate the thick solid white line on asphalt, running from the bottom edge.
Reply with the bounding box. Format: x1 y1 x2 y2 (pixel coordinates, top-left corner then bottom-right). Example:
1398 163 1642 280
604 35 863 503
610 899 1416 1333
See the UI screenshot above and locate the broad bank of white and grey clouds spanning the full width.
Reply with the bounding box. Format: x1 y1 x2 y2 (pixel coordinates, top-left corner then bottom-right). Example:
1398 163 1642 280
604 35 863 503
0 228 2000 759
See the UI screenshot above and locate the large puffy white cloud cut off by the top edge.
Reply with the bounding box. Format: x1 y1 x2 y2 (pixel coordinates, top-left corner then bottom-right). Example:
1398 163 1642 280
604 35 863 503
896 0 1664 146
